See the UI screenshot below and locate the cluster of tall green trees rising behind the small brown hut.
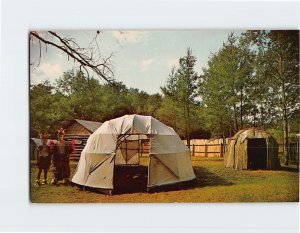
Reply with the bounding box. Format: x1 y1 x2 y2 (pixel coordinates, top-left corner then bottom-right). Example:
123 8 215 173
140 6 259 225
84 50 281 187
199 31 300 141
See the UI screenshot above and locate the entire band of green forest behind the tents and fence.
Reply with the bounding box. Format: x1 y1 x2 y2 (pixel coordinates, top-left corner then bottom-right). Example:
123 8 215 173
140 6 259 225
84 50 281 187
30 30 300 161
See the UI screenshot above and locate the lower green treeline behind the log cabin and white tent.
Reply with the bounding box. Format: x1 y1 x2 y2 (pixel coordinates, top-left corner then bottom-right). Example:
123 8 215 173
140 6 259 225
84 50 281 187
30 70 161 137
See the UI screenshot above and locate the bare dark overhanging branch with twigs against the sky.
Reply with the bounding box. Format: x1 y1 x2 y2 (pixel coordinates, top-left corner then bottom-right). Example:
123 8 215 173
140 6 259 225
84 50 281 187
29 31 114 84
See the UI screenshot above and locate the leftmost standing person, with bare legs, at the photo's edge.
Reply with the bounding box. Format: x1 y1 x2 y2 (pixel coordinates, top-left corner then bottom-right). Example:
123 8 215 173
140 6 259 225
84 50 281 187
35 134 51 186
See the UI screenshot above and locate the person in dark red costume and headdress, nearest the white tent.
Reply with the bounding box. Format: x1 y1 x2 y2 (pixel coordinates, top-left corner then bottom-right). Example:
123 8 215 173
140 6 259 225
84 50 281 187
51 128 72 184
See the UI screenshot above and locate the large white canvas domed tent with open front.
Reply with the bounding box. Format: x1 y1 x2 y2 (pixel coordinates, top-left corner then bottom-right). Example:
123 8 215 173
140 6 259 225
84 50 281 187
72 115 195 193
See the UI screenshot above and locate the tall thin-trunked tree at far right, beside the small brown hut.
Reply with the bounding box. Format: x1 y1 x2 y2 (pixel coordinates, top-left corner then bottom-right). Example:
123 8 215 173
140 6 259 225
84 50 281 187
245 30 299 165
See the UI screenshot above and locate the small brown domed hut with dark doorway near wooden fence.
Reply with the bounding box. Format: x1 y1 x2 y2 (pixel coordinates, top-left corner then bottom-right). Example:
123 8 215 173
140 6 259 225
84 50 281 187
224 128 280 169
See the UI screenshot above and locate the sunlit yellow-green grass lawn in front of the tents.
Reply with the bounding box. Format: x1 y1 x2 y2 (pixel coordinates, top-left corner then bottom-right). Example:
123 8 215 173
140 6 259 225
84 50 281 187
30 157 299 203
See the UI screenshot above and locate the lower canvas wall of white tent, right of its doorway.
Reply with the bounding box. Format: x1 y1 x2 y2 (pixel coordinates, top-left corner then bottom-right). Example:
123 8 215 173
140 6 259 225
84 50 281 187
148 152 196 187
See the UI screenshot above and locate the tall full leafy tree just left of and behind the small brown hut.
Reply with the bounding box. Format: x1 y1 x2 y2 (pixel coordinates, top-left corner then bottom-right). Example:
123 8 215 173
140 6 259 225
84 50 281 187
199 33 253 135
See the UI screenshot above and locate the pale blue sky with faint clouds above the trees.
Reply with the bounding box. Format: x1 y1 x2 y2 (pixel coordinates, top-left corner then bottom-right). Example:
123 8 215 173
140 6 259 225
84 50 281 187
30 30 242 94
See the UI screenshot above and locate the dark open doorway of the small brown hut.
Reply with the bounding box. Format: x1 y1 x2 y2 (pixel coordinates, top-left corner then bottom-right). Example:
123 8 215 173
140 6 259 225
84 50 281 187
247 138 267 169
